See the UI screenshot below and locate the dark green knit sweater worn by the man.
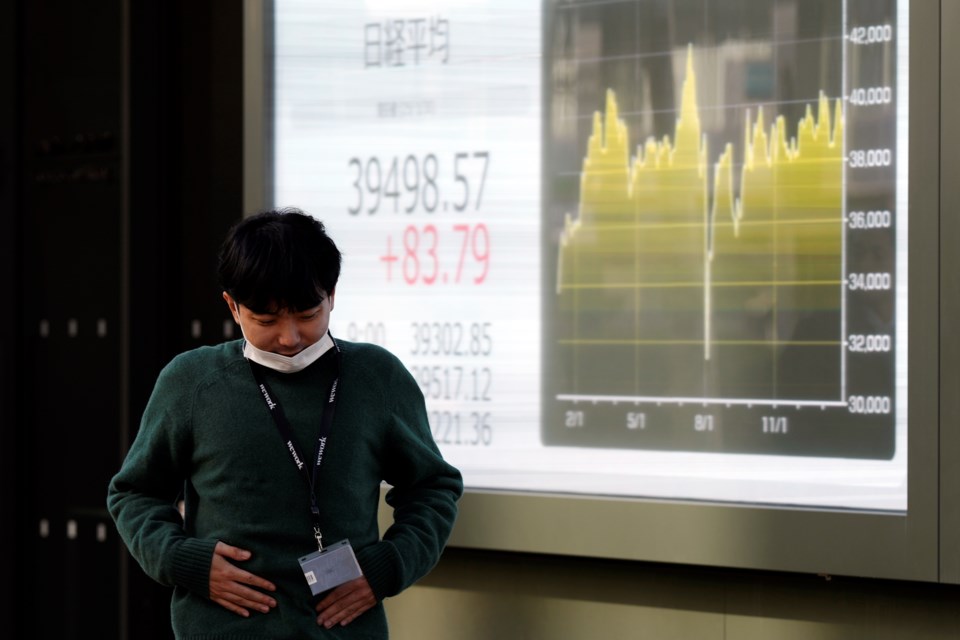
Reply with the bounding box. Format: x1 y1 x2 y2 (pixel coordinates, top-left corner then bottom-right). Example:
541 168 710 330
107 340 463 640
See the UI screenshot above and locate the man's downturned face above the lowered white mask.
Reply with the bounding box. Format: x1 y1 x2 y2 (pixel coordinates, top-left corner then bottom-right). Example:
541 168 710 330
223 291 333 357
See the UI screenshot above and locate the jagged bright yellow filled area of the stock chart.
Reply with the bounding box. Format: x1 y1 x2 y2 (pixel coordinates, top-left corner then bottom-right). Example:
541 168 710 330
556 46 844 359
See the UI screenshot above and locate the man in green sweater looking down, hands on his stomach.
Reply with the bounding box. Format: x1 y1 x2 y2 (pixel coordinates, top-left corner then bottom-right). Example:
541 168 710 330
107 209 463 639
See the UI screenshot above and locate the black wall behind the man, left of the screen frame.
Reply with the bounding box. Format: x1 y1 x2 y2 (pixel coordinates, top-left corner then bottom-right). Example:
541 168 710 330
0 0 243 639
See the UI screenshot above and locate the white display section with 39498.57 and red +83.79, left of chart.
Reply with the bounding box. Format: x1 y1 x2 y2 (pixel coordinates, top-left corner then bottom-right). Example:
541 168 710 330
276 0 541 464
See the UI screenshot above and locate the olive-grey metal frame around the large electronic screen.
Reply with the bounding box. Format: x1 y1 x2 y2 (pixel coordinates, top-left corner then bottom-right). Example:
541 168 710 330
244 0 944 582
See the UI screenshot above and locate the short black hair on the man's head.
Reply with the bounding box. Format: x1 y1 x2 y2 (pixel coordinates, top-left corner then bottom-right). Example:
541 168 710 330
217 208 342 313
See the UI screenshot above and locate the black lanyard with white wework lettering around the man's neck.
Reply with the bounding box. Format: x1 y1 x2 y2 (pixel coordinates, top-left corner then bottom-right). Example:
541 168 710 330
247 336 343 551
